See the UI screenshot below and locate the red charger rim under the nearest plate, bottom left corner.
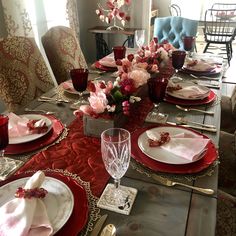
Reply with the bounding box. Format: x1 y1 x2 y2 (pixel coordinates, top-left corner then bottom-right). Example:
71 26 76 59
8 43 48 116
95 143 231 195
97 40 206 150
0 171 88 236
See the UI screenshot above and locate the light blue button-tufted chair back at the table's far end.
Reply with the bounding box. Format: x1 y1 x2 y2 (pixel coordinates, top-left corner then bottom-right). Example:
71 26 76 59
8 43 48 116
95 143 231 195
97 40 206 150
153 16 198 49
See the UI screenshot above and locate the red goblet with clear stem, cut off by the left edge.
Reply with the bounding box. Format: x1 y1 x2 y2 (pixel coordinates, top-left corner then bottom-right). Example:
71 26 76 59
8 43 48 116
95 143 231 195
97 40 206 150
0 115 9 173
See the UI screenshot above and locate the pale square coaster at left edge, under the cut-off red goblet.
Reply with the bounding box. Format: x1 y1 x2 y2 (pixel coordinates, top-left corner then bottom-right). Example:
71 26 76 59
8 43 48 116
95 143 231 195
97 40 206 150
0 157 24 180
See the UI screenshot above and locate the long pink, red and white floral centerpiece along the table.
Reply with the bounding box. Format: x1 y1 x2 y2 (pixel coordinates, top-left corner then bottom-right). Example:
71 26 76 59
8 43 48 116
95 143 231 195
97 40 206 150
75 39 174 136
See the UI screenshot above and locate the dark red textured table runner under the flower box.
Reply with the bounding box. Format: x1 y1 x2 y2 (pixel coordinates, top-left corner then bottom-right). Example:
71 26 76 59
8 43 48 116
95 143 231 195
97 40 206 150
18 98 152 196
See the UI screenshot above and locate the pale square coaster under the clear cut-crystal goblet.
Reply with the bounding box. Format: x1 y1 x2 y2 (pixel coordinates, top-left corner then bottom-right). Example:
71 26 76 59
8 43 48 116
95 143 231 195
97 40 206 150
97 183 138 215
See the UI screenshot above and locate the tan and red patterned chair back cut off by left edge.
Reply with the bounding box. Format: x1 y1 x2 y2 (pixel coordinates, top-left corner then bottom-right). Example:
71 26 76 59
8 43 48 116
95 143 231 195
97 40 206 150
0 37 54 111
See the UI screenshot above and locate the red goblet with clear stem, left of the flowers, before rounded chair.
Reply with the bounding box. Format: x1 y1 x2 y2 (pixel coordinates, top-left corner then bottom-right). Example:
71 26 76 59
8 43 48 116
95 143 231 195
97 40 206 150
70 68 88 106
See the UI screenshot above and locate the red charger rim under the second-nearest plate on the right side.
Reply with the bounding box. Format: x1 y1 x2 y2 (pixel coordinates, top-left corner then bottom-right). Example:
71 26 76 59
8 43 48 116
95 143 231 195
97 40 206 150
164 90 216 105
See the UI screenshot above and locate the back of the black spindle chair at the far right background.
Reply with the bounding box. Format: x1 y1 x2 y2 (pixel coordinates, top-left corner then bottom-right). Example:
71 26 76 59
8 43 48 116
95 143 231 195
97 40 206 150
204 9 236 44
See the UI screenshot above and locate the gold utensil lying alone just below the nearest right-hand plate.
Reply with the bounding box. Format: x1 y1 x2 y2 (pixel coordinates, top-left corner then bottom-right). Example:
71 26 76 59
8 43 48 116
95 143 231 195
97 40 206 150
151 174 214 195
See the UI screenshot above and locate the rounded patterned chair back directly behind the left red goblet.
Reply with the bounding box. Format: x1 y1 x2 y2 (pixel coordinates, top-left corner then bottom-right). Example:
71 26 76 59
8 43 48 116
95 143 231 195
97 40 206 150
42 26 87 84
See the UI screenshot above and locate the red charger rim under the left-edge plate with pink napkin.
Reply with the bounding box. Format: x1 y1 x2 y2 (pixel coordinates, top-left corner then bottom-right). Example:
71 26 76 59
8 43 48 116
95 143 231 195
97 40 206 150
5 115 64 155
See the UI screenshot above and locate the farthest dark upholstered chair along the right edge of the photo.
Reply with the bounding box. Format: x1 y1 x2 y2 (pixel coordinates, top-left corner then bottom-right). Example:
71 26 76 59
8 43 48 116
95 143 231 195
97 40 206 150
220 86 236 133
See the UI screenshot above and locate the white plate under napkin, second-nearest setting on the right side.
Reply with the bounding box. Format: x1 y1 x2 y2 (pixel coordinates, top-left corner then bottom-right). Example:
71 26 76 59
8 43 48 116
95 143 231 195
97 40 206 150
166 81 211 100
